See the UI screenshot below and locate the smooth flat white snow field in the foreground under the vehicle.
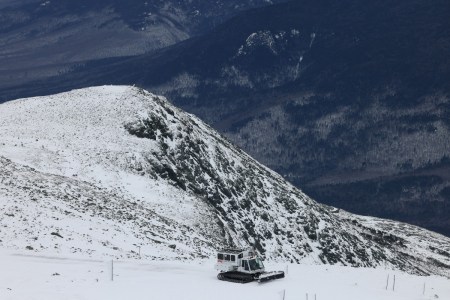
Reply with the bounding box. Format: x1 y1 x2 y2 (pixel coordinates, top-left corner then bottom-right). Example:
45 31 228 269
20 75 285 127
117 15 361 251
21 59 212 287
0 251 450 300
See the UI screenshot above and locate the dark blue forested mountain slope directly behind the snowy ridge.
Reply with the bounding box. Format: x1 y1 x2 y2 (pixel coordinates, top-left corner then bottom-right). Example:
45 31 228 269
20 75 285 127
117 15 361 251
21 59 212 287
3 0 450 235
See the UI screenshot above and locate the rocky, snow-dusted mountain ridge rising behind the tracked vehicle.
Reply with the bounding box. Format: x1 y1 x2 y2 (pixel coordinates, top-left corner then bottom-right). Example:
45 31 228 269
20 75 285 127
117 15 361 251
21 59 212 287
0 86 450 277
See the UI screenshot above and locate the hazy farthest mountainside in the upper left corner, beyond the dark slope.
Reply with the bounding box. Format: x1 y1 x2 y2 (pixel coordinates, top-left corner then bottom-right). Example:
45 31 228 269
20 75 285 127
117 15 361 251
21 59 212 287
0 0 288 95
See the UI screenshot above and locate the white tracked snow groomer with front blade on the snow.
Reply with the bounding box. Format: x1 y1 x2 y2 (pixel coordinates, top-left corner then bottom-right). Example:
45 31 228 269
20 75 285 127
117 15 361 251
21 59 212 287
216 249 284 283
